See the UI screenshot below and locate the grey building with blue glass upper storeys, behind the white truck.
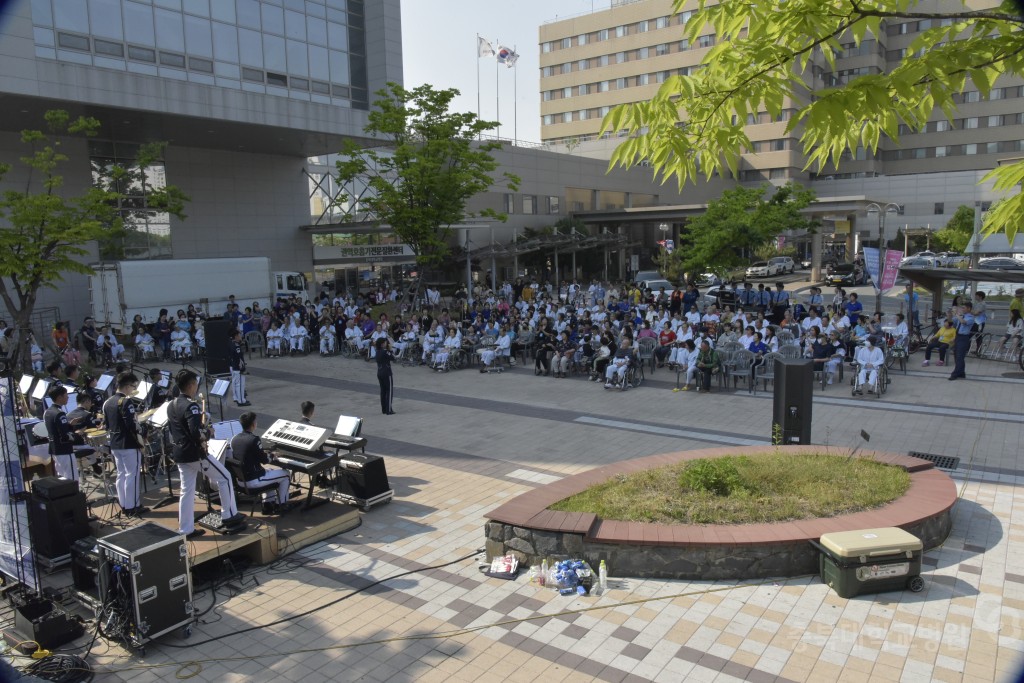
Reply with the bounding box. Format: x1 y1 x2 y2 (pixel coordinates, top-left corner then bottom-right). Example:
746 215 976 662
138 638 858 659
0 0 402 321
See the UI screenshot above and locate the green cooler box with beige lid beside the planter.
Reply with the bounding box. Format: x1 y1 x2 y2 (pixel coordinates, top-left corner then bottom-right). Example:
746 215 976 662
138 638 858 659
812 526 925 598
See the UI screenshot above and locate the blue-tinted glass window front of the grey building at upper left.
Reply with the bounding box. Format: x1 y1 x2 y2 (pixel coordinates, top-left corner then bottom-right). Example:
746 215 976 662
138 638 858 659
32 0 369 110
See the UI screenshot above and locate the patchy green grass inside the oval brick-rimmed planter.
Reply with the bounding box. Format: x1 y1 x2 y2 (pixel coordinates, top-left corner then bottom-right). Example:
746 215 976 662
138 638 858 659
550 454 910 524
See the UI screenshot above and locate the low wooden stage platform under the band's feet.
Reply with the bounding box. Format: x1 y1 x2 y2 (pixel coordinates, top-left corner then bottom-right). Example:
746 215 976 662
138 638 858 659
91 488 361 568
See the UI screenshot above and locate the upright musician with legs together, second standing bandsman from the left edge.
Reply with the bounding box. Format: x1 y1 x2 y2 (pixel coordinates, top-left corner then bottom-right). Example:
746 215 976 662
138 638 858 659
103 372 150 516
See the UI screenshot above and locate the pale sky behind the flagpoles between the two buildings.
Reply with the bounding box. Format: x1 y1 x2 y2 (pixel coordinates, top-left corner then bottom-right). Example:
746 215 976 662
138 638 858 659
401 0 609 142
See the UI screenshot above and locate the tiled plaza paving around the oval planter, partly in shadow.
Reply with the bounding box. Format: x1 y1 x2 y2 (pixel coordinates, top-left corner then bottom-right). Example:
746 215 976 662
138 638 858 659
25 313 1024 683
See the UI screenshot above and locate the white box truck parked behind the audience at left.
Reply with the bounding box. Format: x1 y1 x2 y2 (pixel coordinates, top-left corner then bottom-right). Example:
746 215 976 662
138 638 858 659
89 256 307 334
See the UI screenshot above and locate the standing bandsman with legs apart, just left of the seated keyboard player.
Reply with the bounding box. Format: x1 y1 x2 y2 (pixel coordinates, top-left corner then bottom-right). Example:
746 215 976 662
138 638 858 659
167 370 244 539
